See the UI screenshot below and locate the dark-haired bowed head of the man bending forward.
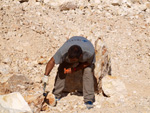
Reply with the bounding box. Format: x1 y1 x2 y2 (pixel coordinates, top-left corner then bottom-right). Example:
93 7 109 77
68 45 82 62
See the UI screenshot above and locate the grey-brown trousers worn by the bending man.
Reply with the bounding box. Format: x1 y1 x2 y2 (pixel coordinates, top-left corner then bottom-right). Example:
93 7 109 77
53 62 95 102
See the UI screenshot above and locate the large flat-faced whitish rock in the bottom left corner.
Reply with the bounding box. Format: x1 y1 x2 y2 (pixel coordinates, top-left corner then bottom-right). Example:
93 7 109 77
0 92 32 113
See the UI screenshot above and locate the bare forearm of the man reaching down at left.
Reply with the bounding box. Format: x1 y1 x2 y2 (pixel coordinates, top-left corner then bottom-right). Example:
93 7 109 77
44 57 55 76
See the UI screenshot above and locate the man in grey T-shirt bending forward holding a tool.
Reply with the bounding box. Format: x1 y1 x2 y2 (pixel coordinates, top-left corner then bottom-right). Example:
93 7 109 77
43 36 95 109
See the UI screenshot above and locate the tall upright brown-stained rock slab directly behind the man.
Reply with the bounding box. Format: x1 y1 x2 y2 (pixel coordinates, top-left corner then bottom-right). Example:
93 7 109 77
94 38 111 93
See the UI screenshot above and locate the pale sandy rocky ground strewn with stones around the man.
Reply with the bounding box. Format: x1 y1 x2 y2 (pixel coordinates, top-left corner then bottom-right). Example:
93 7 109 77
0 0 150 113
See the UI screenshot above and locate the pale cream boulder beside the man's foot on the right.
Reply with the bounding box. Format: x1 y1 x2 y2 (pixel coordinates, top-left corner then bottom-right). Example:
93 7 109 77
102 76 128 103
